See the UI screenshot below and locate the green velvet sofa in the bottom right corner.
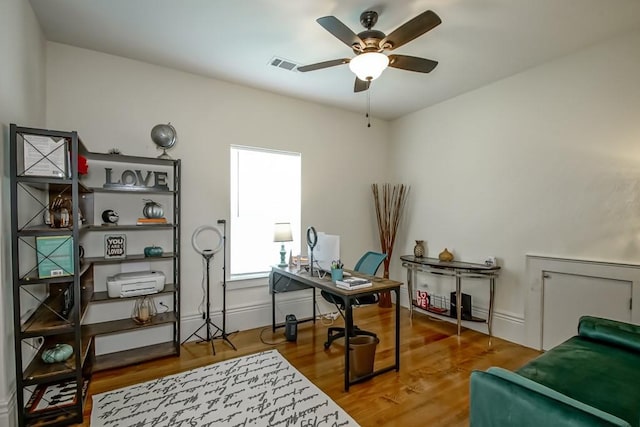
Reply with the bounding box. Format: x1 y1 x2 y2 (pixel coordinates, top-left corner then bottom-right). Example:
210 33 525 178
469 316 640 427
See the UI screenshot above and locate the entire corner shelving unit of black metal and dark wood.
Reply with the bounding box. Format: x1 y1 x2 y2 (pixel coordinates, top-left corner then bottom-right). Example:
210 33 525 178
10 124 180 426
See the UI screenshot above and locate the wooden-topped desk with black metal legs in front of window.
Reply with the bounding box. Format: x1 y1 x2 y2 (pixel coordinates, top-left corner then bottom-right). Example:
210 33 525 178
269 267 402 391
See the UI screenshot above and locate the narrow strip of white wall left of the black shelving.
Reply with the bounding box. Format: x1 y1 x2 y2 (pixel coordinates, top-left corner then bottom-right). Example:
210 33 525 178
0 0 45 426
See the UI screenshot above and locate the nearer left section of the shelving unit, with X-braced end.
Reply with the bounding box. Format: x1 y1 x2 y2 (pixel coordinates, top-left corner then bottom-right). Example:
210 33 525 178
10 124 93 426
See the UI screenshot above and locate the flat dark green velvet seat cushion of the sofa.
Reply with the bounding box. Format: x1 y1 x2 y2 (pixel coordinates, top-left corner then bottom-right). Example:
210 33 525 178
516 336 640 426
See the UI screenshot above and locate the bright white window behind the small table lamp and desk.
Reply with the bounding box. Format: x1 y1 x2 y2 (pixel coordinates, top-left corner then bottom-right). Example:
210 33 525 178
229 146 301 278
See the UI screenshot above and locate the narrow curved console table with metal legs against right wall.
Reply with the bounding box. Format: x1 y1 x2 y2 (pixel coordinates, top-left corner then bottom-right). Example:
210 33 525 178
400 255 500 339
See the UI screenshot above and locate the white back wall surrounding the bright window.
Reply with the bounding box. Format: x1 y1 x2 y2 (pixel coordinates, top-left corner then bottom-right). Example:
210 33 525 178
47 43 389 337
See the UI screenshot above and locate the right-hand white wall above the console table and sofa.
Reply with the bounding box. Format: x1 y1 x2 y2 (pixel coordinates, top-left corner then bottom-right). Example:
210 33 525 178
391 31 640 342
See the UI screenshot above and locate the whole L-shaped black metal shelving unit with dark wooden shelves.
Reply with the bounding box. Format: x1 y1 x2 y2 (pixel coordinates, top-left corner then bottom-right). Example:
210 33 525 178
9 124 181 426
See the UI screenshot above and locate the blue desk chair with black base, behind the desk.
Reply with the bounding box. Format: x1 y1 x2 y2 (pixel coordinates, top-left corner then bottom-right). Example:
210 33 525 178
320 251 387 350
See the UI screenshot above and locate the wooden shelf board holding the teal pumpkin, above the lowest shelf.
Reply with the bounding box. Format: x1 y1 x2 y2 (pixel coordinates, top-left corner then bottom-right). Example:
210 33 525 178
23 334 93 385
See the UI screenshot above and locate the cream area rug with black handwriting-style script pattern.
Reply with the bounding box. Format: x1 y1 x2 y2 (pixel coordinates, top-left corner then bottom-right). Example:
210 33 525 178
91 350 358 427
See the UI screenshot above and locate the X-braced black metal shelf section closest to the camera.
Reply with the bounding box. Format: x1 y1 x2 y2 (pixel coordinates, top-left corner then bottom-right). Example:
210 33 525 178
9 124 86 426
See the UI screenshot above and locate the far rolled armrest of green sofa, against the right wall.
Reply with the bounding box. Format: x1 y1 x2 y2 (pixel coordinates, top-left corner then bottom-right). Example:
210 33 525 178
578 316 640 352
